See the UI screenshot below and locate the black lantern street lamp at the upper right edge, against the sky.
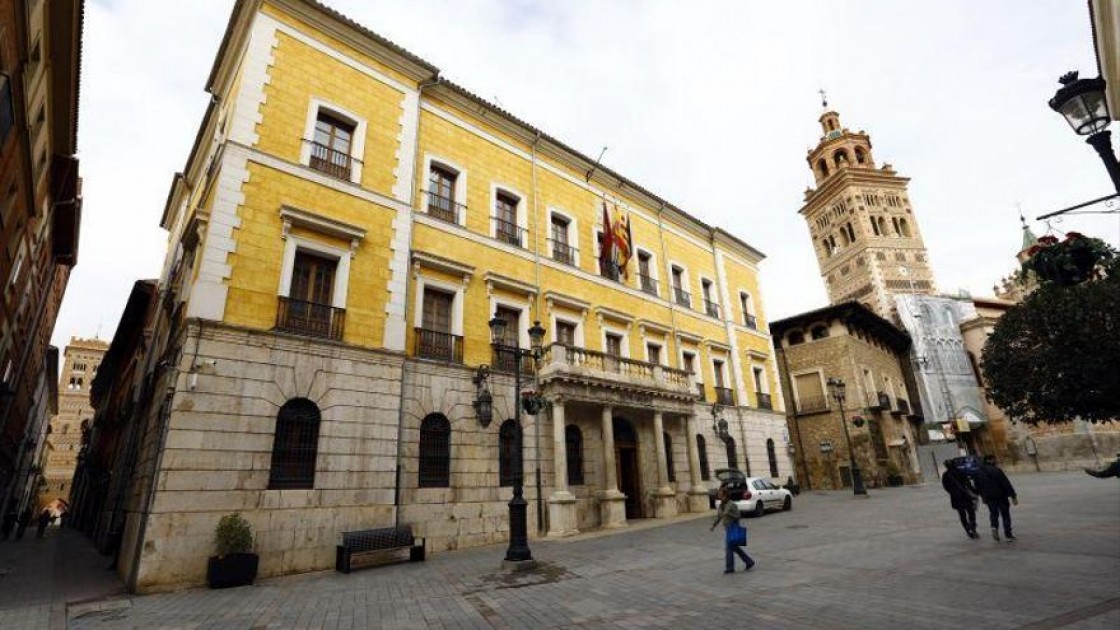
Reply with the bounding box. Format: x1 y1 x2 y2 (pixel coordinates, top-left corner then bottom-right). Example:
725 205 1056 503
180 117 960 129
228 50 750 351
1049 72 1120 194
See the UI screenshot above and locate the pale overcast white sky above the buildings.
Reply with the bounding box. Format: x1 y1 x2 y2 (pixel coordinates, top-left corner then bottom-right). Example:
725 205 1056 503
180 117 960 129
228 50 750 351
53 0 1120 348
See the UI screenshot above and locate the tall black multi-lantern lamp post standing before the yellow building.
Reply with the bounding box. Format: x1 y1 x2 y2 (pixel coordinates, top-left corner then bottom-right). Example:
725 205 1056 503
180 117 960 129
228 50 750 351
487 314 544 563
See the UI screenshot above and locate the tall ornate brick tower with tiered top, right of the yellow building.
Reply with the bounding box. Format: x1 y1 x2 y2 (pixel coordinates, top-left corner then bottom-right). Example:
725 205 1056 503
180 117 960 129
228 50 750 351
800 110 936 322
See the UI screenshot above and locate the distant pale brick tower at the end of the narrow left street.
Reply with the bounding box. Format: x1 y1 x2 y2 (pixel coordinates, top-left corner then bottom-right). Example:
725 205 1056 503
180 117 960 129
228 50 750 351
40 337 109 503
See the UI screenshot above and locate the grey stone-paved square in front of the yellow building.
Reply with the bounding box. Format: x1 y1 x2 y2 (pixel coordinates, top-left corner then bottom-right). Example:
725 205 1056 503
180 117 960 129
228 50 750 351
6 473 1120 630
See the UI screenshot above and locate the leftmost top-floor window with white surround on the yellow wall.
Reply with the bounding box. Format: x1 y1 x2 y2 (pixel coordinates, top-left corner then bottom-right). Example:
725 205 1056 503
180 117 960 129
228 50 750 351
300 99 366 182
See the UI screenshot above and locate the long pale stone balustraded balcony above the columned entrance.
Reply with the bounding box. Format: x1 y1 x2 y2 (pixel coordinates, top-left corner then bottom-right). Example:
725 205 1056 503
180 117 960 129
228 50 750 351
540 343 693 396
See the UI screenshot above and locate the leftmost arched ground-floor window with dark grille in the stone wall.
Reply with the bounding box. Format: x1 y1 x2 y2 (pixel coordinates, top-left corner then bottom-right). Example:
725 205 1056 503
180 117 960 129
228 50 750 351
269 398 321 489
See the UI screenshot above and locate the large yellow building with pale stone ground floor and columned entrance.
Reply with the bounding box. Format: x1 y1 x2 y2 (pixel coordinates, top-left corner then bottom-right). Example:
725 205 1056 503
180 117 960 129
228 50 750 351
119 0 793 591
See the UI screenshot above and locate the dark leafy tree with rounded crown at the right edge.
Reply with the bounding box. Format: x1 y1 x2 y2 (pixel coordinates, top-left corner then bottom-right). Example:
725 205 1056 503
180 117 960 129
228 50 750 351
981 254 1120 424
